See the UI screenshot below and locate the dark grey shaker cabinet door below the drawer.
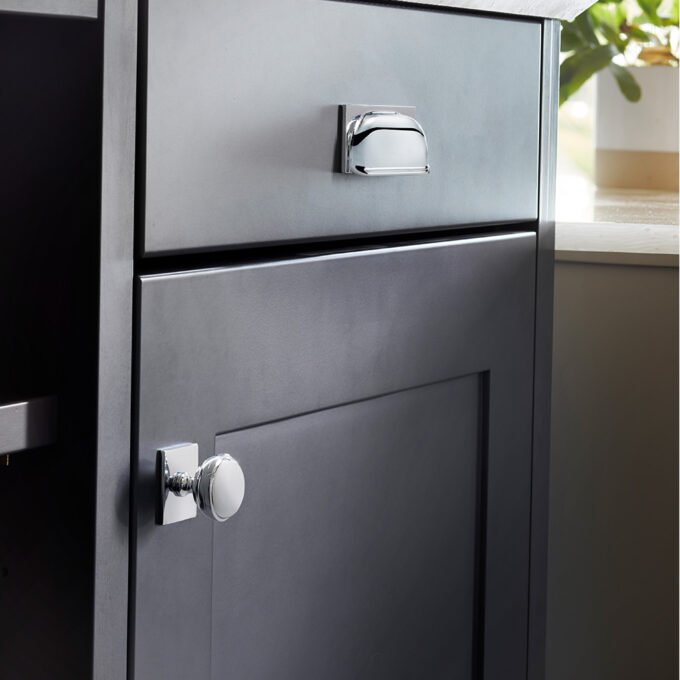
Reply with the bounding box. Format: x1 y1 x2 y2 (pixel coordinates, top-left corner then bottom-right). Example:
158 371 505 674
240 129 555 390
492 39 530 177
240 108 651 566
132 233 535 680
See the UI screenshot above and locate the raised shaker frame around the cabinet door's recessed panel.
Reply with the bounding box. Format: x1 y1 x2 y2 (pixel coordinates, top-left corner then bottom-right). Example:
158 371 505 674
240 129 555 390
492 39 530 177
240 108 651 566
133 233 535 680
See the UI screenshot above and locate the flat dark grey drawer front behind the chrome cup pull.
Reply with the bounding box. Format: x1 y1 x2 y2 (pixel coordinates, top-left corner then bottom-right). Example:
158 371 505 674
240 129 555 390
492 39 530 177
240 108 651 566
140 0 541 254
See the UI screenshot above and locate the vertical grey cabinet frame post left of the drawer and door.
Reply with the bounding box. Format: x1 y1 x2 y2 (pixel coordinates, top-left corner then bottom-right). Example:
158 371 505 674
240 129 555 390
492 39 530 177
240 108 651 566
92 0 137 680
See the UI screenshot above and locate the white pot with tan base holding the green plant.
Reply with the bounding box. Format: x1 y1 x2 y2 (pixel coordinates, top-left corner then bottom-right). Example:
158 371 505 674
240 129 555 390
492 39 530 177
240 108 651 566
595 66 680 191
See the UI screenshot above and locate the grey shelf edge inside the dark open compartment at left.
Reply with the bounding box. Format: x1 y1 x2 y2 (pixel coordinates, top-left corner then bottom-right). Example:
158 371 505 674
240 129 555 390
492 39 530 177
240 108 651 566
0 397 57 454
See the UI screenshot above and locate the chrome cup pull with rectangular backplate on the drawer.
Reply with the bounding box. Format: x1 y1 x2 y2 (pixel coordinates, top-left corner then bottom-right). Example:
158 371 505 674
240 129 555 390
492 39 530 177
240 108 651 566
342 104 430 176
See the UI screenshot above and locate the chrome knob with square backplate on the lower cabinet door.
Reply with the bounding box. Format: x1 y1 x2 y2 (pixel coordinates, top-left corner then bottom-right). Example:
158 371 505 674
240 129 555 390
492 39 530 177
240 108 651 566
158 444 245 524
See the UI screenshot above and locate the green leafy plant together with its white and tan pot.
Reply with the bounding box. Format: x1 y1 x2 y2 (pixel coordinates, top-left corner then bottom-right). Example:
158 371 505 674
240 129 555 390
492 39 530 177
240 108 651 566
560 0 680 191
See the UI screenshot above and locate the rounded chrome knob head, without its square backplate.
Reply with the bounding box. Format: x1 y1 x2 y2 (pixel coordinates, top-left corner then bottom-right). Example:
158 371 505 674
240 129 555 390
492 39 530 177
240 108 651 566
192 453 246 522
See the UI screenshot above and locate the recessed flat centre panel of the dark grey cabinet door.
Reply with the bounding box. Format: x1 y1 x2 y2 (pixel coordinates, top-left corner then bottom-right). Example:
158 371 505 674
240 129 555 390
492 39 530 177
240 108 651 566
211 375 478 680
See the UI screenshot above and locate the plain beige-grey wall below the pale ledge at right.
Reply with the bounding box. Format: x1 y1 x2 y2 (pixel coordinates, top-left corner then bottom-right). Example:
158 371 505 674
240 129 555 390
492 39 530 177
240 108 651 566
547 262 678 680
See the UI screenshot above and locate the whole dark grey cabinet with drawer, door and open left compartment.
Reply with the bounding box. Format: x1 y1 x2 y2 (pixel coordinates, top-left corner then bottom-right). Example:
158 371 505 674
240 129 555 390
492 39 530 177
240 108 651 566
0 0 564 680
